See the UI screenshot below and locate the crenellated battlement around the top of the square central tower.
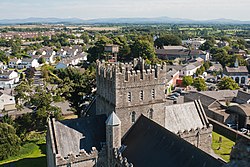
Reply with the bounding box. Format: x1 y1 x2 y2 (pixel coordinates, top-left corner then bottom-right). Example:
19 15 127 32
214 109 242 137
97 58 167 83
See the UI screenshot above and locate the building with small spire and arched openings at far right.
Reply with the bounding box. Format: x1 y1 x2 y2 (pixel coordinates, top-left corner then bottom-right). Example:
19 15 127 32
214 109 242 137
223 59 248 85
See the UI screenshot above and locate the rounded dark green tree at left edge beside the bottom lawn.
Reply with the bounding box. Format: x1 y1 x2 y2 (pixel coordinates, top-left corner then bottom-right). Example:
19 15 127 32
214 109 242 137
0 123 21 160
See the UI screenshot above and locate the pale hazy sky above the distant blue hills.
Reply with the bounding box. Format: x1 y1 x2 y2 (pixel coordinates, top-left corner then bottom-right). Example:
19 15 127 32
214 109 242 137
0 0 250 21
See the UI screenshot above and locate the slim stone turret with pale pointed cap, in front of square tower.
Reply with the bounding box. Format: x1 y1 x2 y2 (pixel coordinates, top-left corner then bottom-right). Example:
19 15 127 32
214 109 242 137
106 112 121 166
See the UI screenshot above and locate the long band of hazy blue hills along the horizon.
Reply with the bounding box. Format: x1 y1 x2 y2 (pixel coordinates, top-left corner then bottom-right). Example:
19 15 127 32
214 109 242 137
0 17 250 24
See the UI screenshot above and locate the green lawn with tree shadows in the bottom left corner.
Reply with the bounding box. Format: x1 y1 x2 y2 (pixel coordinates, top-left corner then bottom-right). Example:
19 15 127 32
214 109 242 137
0 132 46 167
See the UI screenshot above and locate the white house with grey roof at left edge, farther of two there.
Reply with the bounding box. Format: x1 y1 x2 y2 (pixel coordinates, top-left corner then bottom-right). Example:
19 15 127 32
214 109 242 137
0 70 19 88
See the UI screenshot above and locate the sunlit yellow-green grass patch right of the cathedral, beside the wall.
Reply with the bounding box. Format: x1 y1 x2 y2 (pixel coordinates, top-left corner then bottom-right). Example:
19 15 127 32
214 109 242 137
212 132 235 162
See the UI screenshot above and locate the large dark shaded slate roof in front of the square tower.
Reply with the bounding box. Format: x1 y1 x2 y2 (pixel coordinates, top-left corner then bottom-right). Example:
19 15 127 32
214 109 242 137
122 115 223 167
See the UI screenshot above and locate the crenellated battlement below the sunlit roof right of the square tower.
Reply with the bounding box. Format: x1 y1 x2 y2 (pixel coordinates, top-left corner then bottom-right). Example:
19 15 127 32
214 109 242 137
177 124 213 138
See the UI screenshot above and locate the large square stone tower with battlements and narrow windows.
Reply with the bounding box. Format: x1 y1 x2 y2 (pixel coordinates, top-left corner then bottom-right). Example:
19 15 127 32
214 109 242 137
96 58 170 135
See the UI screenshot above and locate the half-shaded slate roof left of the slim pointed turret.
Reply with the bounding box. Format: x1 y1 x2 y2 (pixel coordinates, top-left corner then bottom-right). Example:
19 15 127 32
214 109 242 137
53 115 106 157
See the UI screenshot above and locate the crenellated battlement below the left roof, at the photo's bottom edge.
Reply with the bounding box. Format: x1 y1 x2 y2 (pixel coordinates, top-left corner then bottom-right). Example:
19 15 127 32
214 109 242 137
56 147 98 166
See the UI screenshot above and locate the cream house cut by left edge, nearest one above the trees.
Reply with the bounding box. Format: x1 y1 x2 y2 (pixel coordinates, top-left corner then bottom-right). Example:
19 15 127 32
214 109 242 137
0 92 16 112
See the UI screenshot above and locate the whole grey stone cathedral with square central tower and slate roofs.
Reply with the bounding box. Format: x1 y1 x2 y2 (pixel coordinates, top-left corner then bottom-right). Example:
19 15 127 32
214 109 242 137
46 59 223 167
